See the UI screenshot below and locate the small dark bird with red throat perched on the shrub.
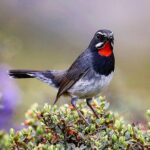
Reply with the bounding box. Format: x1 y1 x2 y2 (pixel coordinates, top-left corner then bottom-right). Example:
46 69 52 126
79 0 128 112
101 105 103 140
9 29 115 122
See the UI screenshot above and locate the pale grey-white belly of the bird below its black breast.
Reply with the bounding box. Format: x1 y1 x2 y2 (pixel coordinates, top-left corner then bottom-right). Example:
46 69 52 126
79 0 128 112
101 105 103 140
68 73 113 98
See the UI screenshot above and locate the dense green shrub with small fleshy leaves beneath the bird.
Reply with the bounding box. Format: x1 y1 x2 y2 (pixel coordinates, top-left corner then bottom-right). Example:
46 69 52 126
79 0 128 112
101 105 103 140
0 98 150 150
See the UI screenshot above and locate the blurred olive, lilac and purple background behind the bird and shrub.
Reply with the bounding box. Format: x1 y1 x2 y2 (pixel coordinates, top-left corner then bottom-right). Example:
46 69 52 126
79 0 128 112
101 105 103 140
0 0 150 129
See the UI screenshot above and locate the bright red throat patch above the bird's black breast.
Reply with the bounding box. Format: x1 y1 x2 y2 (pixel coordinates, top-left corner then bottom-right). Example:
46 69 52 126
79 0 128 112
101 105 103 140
98 42 112 57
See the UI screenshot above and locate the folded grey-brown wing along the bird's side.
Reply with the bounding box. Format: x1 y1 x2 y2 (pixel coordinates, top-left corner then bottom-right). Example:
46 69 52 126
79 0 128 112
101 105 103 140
54 49 90 104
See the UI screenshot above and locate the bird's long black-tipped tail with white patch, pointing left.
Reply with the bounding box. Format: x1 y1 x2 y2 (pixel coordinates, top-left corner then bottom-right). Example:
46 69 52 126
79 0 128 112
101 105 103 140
8 70 65 88
